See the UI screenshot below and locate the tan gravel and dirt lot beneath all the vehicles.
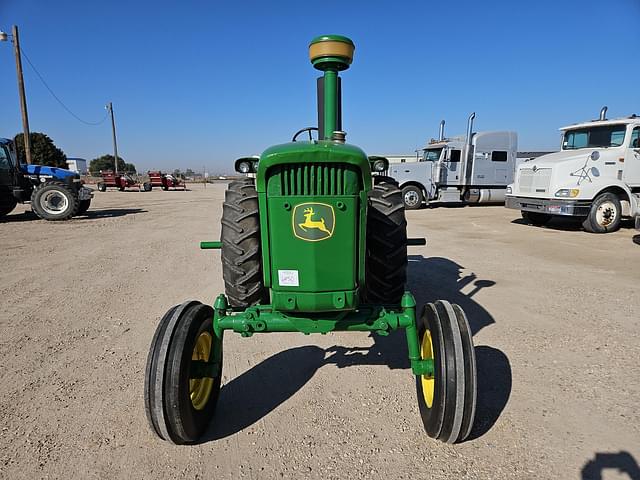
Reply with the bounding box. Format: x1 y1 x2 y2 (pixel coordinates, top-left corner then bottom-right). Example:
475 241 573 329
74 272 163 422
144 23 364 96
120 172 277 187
0 185 640 479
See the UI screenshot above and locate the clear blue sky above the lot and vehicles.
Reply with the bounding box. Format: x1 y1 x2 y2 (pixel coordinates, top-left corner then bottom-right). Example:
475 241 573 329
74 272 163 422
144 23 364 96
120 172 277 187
0 0 640 172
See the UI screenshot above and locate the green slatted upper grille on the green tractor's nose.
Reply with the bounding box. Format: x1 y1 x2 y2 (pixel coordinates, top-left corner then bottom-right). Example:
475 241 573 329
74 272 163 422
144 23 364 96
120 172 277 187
268 163 360 196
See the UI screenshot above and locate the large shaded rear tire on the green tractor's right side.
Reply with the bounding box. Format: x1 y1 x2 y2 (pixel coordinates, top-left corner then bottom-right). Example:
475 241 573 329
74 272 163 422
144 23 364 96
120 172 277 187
365 183 407 304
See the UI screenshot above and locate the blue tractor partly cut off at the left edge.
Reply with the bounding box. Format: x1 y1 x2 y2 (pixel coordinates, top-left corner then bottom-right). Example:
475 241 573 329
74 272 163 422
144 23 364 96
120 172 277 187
0 138 93 220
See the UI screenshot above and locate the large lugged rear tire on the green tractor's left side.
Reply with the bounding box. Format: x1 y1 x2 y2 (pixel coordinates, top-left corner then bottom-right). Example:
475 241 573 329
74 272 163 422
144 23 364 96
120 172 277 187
220 178 269 308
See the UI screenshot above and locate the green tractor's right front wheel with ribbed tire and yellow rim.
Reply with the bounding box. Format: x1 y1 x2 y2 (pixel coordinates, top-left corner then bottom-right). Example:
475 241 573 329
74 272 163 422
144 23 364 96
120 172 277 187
416 300 477 443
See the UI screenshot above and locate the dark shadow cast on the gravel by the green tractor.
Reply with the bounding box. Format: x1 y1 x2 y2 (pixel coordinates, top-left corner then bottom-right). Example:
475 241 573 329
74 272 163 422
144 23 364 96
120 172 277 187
201 255 512 443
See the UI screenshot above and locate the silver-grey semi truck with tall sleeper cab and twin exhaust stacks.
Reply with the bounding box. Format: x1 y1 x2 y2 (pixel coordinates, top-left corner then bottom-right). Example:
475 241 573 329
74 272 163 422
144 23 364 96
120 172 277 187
388 113 518 210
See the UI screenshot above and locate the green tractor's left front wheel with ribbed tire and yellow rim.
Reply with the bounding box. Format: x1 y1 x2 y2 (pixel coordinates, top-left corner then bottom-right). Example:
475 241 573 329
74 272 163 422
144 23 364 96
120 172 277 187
144 301 222 444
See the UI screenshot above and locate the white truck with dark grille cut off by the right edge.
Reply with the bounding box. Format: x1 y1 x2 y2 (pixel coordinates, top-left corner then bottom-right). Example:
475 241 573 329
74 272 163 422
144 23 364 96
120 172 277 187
505 107 640 233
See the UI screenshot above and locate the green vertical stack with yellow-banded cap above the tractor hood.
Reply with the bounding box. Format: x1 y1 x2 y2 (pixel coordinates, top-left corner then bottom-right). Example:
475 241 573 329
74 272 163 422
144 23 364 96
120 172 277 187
309 35 356 140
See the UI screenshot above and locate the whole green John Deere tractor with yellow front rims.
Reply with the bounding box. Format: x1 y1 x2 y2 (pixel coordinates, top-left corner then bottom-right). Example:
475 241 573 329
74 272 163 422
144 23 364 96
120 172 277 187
144 35 476 444
